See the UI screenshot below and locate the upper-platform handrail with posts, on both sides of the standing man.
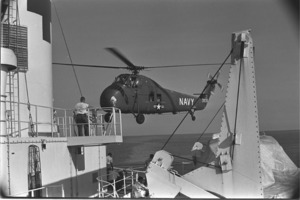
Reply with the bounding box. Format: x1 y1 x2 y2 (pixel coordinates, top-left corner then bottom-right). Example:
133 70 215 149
1 100 122 137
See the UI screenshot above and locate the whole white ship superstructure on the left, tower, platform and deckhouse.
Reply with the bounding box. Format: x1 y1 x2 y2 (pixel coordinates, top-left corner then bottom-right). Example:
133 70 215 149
0 0 123 197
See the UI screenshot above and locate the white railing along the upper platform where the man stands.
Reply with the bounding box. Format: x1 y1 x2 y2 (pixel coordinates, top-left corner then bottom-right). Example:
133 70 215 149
1 99 122 137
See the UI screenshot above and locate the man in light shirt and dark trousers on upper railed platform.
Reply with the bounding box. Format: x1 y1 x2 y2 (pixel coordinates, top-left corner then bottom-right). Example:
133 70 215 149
75 97 89 136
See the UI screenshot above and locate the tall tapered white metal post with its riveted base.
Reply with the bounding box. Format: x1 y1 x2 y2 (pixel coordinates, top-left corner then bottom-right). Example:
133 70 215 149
146 30 264 198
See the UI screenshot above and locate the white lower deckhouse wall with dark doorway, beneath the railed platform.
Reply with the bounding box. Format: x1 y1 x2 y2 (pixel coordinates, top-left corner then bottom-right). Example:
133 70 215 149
0 101 123 197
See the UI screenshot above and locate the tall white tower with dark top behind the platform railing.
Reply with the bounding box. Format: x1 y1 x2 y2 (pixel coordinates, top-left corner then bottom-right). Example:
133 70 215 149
18 0 53 134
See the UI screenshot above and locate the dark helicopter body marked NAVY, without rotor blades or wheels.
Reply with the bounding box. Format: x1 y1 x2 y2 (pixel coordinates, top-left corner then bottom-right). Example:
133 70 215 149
100 74 209 115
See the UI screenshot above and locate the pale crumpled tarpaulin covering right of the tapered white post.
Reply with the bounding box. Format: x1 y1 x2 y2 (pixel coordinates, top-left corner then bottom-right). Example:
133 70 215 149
260 135 299 198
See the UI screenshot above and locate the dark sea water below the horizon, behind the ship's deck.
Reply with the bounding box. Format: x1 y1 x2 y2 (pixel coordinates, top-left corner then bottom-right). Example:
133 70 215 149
107 130 300 172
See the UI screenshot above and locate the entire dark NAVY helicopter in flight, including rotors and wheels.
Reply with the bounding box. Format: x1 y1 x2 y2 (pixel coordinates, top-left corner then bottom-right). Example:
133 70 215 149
53 48 222 124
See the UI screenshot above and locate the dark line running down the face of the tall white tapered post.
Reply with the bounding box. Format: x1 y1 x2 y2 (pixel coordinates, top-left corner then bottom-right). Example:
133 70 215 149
231 42 245 159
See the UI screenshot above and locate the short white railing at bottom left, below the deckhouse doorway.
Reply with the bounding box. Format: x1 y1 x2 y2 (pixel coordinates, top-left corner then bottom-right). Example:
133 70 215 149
10 184 65 198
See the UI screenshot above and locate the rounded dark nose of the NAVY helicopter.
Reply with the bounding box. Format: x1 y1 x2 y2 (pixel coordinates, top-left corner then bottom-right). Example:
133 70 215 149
100 87 121 108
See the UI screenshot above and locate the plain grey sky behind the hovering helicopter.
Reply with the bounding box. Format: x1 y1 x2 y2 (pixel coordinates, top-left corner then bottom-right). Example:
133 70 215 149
52 0 299 135
